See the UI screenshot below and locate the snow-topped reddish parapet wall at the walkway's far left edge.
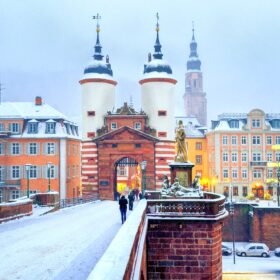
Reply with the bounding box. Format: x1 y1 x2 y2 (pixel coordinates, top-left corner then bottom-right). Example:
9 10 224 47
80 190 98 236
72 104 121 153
0 199 32 223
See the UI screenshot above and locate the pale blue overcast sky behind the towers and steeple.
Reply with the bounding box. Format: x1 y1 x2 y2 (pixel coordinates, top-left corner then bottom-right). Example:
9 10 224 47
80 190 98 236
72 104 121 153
0 0 280 127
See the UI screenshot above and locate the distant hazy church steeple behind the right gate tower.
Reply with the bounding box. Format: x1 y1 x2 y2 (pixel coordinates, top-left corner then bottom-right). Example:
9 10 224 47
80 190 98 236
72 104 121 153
183 26 207 126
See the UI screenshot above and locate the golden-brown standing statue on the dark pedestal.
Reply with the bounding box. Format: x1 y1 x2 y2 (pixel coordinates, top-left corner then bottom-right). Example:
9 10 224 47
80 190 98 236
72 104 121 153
175 120 188 162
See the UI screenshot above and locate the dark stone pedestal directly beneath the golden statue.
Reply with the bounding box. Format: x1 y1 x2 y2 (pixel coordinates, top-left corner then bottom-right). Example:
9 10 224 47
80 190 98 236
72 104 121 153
169 161 194 187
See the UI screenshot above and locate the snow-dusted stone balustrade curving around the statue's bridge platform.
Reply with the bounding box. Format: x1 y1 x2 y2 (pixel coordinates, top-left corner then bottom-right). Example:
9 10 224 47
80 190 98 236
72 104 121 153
147 192 228 220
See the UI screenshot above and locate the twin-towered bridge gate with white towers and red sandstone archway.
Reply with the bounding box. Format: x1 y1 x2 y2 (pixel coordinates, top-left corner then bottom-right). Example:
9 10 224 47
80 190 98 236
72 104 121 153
80 17 177 199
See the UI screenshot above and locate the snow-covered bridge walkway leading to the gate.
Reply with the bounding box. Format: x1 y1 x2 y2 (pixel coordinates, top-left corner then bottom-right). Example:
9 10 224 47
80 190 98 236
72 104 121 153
0 201 125 280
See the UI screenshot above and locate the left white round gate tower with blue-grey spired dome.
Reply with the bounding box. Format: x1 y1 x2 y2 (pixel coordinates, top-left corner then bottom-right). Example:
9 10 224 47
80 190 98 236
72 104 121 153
80 20 117 141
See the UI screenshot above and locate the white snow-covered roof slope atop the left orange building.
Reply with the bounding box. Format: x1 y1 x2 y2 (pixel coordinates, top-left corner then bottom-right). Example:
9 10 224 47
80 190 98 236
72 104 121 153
0 102 66 119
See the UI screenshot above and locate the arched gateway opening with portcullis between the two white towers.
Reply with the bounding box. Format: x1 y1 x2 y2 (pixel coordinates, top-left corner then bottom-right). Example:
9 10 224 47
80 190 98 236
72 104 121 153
114 157 141 200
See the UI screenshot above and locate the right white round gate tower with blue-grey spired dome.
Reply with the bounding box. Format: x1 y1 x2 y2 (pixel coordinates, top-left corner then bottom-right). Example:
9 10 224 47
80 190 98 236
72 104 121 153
139 15 177 141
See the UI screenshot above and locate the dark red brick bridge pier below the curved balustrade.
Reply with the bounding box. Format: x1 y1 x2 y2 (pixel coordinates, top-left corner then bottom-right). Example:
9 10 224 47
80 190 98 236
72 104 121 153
147 219 222 279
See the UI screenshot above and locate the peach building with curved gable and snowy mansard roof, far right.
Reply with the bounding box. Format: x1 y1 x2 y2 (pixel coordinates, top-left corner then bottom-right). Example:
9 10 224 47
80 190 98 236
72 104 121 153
207 109 280 198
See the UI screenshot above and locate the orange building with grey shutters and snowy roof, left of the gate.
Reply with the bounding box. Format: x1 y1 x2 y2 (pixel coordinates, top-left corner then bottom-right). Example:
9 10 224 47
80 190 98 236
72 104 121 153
0 97 80 203
